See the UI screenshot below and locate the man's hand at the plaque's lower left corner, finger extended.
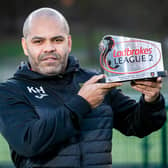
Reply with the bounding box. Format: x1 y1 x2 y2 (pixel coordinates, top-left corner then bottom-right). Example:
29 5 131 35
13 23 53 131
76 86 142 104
78 75 122 108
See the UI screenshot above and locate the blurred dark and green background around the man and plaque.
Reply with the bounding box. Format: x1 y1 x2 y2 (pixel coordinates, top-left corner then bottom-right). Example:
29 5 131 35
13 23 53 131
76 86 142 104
0 0 168 168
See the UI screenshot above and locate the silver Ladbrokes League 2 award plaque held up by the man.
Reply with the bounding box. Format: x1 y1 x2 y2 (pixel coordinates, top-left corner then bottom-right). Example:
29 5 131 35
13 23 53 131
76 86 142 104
99 35 167 82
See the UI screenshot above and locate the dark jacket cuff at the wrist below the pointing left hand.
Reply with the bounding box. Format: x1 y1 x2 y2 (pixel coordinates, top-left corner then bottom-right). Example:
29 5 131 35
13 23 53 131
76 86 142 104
65 95 91 118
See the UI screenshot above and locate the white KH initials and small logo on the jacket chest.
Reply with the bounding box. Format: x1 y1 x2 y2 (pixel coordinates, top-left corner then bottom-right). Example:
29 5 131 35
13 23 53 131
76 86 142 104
27 86 48 99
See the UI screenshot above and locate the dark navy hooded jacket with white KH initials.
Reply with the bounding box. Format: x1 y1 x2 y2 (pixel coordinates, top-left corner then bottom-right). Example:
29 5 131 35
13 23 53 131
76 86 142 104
0 57 166 168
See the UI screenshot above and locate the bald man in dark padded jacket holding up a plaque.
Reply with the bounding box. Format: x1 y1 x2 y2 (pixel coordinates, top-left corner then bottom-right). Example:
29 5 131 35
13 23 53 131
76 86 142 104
0 8 166 168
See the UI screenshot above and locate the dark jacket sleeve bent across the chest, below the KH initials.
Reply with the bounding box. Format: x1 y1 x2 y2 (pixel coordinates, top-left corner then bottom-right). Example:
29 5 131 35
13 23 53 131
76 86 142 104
0 88 90 157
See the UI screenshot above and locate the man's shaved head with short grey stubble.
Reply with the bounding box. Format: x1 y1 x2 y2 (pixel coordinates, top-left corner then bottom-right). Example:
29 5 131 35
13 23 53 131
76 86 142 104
22 8 72 76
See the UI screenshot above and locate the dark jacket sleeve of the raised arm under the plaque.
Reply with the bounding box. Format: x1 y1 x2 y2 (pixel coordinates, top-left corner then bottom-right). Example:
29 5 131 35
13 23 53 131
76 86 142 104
111 89 166 138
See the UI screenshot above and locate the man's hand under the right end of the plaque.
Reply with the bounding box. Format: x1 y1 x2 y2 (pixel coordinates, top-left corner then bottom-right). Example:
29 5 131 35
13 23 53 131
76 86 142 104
131 77 162 103
